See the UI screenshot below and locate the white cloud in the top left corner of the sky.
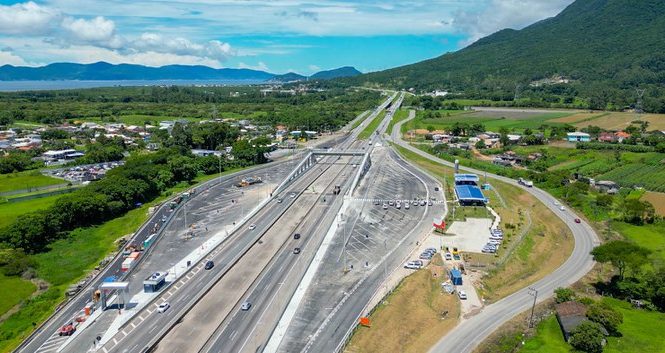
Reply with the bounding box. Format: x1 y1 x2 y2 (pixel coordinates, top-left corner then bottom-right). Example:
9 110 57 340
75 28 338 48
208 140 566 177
0 1 61 34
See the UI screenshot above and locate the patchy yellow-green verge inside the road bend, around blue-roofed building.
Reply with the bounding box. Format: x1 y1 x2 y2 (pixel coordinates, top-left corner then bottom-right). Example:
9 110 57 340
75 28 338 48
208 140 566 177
396 147 574 301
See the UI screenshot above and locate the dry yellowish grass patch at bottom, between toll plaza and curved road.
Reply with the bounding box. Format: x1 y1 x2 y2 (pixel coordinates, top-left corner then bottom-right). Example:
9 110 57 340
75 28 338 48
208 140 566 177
345 270 460 353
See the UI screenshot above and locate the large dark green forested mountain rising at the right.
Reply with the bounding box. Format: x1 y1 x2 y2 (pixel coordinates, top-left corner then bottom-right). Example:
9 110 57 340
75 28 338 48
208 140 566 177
345 0 665 111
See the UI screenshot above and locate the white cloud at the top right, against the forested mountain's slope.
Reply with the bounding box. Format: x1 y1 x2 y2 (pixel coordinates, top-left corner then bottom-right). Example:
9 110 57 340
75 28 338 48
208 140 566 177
452 0 573 43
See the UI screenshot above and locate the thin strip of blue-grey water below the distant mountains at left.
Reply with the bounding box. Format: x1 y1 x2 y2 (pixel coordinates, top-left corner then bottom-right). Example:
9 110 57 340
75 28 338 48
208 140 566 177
0 80 263 92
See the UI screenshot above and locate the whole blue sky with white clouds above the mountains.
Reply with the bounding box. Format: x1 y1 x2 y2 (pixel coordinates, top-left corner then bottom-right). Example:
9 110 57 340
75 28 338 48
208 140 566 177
0 0 573 74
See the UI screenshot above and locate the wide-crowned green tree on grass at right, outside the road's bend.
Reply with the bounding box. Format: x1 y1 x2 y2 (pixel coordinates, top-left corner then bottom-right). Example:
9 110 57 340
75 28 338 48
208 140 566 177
591 240 651 280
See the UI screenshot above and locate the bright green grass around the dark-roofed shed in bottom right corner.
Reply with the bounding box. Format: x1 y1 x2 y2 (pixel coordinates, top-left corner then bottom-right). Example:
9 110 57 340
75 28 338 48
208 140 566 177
519 298 665 353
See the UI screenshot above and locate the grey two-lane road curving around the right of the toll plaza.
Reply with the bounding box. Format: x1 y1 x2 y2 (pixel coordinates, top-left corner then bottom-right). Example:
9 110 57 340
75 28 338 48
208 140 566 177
391 110 600 353
